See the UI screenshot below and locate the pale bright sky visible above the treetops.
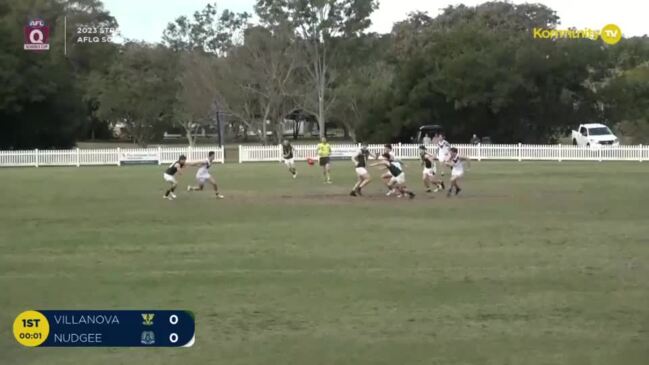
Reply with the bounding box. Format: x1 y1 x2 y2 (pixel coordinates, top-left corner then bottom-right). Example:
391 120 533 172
103 0 649 42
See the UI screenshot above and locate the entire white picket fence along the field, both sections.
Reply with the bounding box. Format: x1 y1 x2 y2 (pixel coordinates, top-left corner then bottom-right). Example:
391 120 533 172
0 144 649 167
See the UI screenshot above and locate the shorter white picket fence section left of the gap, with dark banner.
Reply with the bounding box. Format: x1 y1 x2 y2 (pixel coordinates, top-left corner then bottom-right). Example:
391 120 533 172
0 147 225 167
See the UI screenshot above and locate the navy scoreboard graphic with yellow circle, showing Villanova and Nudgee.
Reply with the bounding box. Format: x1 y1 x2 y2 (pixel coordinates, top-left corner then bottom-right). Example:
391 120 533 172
13 310 195 347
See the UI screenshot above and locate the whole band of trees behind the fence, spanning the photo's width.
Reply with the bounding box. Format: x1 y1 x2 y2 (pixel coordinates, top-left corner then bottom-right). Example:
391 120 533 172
0 0 649 149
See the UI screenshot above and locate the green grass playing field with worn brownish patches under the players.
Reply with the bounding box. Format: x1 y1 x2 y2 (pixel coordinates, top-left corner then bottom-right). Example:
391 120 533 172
0 162 649 365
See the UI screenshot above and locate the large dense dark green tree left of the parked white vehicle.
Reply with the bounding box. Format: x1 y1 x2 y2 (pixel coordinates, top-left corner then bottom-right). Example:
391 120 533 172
365 2 608 142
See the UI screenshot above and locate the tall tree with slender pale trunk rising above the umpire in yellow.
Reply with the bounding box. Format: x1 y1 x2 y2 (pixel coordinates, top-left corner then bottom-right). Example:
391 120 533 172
255 0 378 137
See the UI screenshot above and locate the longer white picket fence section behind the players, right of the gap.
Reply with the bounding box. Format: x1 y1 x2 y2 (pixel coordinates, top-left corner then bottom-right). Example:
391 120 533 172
239 144 649 163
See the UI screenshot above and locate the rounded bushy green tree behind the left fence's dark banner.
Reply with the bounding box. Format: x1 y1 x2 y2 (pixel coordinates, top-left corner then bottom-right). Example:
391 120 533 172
93 43 176 146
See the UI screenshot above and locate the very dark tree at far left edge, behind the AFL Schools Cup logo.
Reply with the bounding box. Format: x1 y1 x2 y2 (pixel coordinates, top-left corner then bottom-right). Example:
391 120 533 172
0 1 86 149
